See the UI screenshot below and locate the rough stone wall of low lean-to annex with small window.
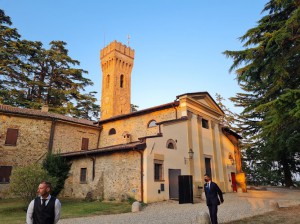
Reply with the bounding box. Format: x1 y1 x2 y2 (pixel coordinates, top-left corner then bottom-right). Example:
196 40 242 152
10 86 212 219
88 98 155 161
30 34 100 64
62 151 141 201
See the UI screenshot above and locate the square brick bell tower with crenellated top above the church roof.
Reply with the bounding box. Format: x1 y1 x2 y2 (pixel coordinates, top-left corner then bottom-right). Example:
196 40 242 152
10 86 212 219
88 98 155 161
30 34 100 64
100 41 134 120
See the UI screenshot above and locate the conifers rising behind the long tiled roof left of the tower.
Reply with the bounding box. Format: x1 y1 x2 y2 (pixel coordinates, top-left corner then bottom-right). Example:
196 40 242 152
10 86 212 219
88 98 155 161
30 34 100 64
0 10 100 119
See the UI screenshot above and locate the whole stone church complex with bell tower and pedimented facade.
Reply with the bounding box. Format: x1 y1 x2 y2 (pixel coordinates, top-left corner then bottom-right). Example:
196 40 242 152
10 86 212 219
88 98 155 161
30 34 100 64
0 41 246 203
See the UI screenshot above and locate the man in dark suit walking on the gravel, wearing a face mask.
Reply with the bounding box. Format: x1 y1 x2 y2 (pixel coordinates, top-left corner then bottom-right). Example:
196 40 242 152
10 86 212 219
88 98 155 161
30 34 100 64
204 174 224 224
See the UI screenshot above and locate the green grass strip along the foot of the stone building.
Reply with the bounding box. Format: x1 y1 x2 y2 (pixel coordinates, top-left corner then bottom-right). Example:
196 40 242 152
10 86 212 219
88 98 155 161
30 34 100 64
0 199 131 224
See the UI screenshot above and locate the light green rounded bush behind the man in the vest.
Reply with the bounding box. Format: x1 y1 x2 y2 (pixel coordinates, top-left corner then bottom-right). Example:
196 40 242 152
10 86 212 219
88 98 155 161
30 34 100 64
9 164 56 204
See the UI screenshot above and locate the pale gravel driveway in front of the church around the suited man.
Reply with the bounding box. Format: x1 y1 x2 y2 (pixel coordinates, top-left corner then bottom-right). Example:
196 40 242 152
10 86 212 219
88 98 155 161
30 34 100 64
59 188 300 224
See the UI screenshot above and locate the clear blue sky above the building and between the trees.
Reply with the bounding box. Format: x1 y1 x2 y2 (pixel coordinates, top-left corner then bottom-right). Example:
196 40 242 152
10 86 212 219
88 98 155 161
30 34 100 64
0 0 268 112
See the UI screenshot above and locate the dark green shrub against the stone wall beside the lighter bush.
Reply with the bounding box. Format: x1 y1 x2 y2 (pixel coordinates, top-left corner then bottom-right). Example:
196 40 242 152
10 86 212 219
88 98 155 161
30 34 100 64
43 153 71 196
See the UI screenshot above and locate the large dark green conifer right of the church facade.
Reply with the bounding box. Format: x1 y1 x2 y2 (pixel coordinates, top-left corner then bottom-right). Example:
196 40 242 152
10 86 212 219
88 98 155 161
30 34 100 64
224 0 300 186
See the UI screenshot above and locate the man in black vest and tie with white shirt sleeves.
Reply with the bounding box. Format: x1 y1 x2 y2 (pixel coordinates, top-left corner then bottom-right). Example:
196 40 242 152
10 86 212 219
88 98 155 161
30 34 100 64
26 181 61 224
